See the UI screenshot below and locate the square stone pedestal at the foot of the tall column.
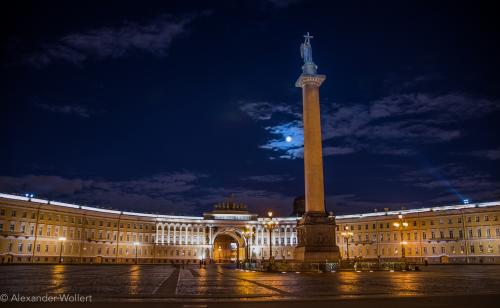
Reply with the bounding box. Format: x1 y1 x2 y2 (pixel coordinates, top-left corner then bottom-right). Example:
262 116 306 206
294 212 340 263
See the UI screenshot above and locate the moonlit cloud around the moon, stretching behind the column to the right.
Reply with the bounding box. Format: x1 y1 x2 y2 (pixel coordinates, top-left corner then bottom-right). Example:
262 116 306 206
252 93 500 159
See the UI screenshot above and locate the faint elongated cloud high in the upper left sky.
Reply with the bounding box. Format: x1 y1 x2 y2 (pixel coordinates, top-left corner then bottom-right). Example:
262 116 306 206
27 15 200 67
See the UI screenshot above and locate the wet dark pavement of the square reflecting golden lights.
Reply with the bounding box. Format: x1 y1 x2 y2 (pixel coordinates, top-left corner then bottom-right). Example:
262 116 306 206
0 265 500 307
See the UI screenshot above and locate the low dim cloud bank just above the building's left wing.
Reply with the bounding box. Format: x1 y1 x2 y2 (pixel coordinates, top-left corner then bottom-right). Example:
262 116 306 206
0 171 208 213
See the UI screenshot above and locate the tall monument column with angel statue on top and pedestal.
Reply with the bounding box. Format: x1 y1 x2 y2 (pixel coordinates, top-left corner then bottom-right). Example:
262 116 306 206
295 33 340 262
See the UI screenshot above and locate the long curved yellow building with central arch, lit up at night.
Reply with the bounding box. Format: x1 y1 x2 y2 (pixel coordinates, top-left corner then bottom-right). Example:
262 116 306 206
0 194 500 264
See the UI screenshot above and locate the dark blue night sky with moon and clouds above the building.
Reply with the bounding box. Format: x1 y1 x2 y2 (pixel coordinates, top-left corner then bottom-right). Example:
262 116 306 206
0 0 500 215
